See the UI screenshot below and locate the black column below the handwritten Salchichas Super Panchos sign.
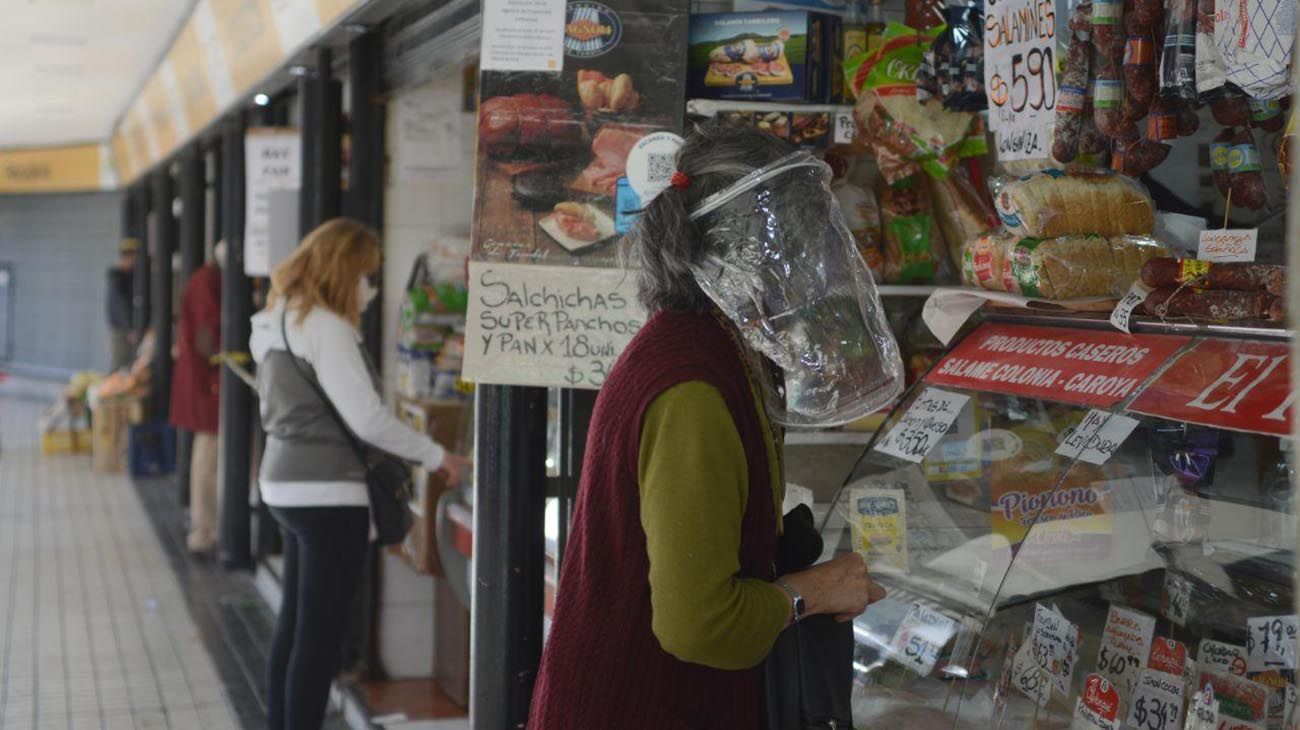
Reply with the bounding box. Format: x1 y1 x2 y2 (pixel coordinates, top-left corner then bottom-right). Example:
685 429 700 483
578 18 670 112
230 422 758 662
469 386 546 730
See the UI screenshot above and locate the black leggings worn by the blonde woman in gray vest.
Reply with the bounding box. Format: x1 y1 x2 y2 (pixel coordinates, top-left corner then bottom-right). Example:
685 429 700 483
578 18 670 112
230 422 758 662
267 507 371 730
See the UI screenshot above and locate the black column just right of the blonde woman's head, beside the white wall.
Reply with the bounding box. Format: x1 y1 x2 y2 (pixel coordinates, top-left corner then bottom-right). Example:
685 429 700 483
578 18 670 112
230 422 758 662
345 31 385 370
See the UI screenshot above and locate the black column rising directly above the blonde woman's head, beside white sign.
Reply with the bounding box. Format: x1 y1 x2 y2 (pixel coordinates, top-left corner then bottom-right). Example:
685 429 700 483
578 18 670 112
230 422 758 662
298 48 343 235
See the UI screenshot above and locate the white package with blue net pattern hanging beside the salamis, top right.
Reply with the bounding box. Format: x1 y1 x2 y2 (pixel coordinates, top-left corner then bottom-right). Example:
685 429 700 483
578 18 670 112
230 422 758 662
1214 0 1296 101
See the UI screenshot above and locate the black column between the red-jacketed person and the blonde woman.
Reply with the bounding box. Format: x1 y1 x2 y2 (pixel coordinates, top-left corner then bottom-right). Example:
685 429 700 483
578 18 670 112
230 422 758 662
218 113 254 570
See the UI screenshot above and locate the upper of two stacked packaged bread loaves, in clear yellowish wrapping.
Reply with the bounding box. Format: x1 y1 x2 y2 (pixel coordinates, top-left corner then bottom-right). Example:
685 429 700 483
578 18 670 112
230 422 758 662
993 170 1156 238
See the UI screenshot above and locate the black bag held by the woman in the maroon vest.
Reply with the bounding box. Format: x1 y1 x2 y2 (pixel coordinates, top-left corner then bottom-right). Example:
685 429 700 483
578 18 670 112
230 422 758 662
763 505 854 730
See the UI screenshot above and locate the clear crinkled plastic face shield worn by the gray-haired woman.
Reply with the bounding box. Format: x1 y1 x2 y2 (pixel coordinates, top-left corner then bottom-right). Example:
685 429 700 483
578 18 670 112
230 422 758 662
692 152 904 426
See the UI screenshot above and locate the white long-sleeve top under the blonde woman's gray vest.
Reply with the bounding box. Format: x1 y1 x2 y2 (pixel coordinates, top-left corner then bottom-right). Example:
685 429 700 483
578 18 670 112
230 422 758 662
250 304 446 507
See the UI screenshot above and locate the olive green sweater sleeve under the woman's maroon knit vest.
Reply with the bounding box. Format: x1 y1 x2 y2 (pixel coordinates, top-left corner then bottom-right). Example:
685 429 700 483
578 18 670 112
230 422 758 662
638 381 790 670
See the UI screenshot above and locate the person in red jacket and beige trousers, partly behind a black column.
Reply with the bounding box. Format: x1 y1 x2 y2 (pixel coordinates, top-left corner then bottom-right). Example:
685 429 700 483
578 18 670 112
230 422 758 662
170 242 226 555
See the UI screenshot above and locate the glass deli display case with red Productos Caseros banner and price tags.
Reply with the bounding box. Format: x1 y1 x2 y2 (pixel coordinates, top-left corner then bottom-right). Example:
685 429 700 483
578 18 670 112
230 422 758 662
823 313 1300 730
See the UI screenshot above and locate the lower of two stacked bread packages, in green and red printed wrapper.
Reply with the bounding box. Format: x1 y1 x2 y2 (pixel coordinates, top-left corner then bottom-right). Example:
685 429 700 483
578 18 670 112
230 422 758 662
1010 235 1165 299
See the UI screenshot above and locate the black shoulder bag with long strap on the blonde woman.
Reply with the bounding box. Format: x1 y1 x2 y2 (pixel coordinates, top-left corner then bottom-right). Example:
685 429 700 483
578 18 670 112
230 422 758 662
280 307 413 546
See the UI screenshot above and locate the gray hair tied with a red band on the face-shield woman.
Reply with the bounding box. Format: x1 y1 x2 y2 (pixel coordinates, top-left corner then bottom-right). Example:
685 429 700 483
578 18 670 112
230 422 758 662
628 121 797 313
